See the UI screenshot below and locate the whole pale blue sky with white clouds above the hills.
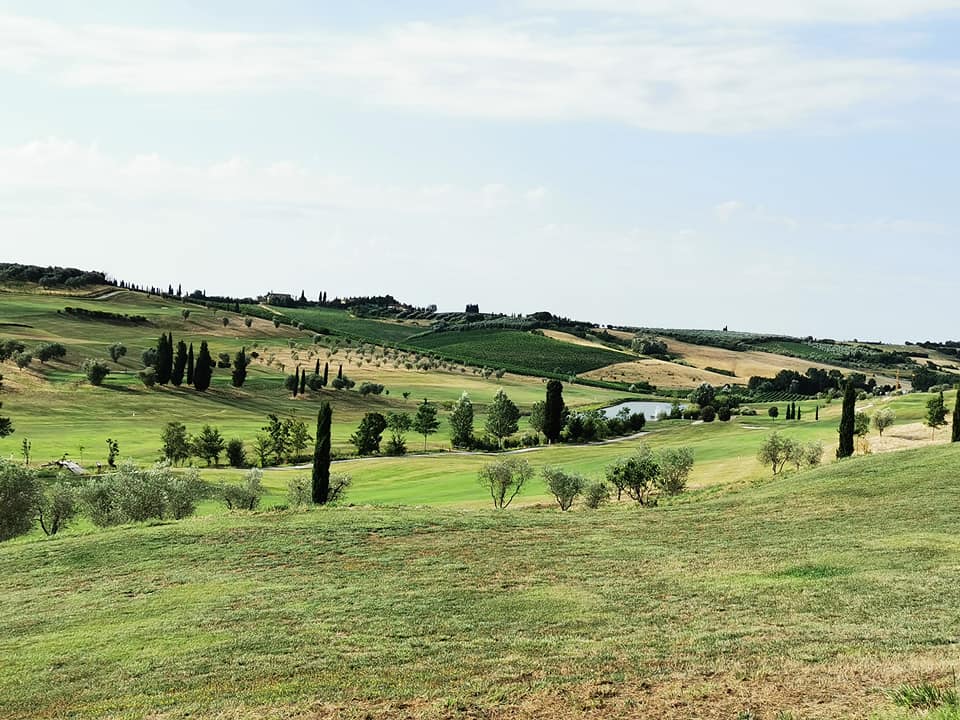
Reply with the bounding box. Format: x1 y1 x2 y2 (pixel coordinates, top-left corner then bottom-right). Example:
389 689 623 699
0 0 960 342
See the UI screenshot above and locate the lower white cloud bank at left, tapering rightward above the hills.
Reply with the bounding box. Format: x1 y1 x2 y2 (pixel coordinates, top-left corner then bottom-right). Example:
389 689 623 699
0 138 546 216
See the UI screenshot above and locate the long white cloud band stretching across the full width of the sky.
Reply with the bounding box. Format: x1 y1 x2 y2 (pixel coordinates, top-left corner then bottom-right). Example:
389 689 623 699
0 11 960 133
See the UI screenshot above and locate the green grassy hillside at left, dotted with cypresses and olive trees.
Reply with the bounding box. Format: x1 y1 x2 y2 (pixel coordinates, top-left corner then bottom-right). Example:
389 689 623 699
0 289 625 464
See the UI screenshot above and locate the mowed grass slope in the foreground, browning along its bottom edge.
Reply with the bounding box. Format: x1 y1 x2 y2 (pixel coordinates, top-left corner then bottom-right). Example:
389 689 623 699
0 447 960 719
